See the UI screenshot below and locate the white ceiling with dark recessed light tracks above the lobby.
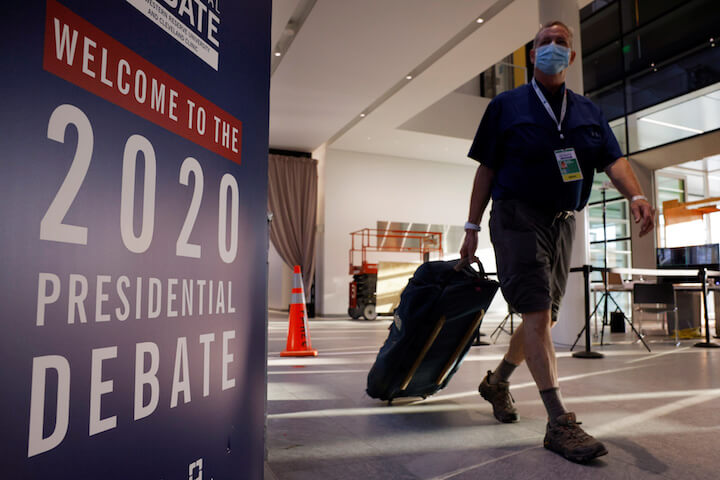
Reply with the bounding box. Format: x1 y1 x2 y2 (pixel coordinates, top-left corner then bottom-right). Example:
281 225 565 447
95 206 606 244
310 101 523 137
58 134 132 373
270 0 589 162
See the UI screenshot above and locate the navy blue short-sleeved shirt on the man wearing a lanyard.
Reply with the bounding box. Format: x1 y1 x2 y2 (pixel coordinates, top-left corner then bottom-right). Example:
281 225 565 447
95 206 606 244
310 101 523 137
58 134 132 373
468 84 622 212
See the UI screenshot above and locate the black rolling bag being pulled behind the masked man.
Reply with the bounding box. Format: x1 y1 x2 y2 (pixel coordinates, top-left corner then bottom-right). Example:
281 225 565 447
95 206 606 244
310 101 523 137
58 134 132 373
367 260 499 402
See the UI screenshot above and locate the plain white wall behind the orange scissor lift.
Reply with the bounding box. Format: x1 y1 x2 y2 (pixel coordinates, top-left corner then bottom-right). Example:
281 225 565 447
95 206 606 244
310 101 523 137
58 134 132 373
317 149 507 315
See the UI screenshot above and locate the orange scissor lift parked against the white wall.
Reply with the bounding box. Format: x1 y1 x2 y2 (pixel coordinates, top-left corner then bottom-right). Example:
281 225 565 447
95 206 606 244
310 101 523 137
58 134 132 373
348 228 443 320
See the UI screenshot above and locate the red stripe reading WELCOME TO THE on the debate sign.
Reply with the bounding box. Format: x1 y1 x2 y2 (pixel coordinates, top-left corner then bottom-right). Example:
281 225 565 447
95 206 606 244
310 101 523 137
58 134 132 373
43 0 242 163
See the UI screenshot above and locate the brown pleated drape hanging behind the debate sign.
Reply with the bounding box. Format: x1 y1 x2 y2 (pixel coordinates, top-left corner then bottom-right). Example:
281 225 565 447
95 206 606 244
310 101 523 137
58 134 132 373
268 155 318 294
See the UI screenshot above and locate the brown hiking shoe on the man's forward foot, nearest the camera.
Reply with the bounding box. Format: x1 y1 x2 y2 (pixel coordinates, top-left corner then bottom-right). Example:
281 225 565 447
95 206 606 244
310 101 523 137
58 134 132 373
543 412 607 463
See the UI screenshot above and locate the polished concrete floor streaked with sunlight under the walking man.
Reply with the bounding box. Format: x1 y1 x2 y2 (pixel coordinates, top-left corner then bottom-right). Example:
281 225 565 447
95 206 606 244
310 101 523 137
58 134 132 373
266 312 720 480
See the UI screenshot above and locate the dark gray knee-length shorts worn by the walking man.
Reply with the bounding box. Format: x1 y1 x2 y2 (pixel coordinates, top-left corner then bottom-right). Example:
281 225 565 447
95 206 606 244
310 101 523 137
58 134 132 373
490 200 575 321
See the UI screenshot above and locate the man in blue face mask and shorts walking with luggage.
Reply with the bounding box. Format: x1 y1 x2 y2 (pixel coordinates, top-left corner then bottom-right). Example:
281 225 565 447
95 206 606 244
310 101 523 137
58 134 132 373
460 22 654 463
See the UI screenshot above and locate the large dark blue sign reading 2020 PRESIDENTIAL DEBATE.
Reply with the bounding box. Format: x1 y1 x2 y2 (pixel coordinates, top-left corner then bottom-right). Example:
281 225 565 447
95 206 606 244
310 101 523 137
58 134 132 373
0 0 271 480
